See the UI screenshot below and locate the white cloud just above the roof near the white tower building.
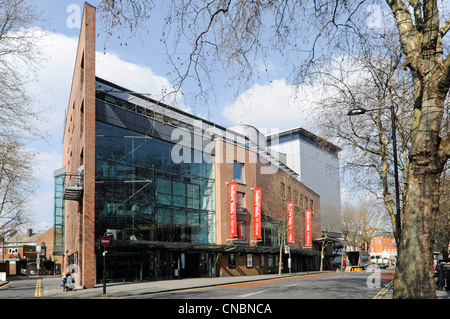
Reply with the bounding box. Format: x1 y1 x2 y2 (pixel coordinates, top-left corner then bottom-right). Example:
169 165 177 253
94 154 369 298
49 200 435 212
222 79 320 132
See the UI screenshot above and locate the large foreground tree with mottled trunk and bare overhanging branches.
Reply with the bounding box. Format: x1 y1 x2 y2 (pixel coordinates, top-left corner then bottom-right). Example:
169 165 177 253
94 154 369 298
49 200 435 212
98 0 450 298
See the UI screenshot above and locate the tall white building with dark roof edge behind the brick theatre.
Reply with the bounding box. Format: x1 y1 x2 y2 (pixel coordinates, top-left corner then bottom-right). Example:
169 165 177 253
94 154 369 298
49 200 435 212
267 127 341 233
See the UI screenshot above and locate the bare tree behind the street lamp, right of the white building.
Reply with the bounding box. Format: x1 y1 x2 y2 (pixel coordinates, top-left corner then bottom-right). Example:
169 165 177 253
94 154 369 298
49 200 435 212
315 46 414 250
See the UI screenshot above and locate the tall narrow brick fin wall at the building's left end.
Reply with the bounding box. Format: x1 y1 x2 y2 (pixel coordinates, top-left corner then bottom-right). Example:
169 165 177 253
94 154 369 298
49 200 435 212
63 4 95 288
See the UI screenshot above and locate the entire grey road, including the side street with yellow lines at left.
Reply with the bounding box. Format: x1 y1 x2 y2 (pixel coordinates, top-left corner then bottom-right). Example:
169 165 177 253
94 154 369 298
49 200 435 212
0 270 393 300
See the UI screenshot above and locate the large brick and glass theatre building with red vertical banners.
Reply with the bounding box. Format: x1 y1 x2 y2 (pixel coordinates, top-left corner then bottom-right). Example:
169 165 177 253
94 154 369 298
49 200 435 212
59 5 321 288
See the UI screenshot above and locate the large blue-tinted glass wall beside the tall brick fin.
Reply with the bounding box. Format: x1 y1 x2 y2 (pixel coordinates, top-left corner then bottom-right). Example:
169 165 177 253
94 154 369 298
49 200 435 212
95 121 215 244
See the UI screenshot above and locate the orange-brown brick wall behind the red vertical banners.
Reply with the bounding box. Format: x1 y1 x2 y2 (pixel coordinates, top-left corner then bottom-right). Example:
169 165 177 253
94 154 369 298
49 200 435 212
215 140 321 276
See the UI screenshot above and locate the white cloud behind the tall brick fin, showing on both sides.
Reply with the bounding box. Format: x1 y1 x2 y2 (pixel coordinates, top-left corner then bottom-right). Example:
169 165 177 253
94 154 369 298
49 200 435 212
28 31 181 225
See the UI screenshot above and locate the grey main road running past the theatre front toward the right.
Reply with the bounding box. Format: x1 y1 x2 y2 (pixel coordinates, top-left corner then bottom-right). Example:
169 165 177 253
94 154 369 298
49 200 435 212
129 270 394 300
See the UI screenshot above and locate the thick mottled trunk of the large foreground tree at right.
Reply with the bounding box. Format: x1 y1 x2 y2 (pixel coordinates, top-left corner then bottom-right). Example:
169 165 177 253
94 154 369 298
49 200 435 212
394 77 448 299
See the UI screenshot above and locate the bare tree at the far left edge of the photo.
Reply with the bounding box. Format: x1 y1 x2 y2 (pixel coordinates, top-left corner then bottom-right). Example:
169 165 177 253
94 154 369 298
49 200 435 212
0 0 44 238
